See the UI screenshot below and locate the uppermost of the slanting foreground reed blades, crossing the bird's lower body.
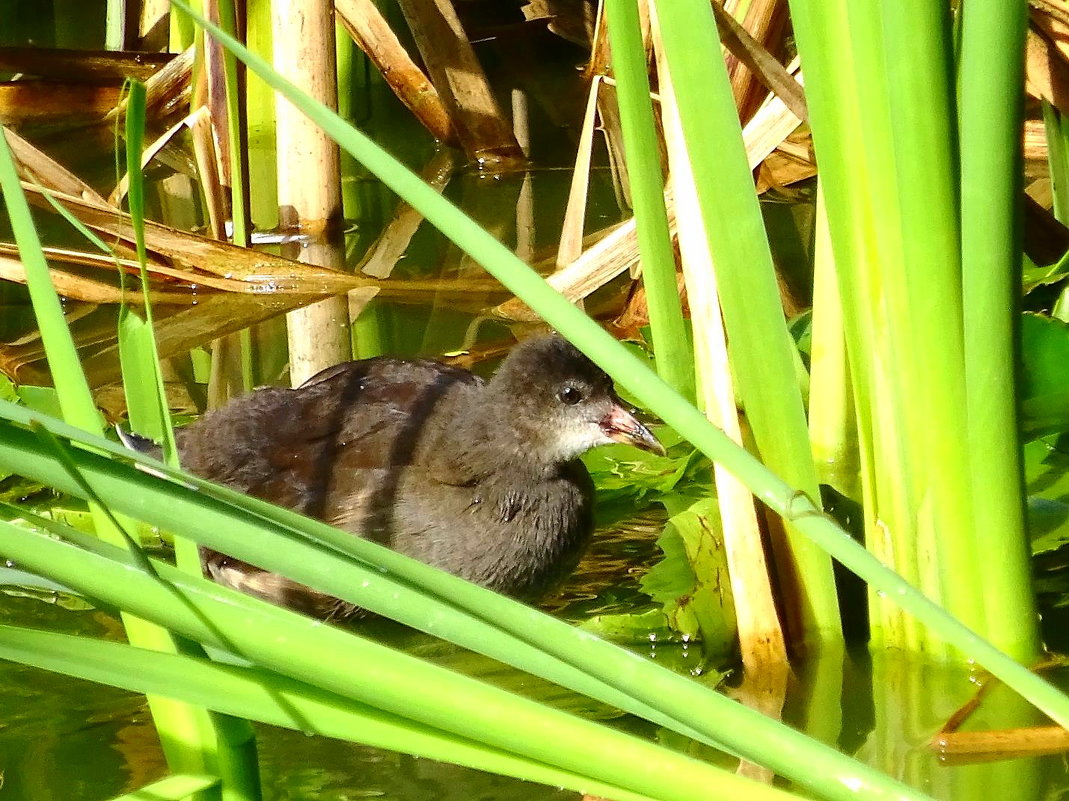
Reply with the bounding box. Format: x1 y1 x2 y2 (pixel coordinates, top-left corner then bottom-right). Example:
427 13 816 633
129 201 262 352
0 407 979 798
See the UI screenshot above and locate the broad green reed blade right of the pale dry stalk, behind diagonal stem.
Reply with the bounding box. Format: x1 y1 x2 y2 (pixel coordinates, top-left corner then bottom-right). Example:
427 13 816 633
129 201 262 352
656 0 841 641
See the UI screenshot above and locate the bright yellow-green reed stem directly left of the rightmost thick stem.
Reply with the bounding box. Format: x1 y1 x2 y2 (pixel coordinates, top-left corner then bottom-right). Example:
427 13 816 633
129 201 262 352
880 0 987 631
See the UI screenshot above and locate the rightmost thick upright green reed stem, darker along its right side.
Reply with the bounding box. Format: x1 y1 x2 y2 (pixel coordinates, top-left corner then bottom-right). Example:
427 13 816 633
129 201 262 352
958 0 1040 662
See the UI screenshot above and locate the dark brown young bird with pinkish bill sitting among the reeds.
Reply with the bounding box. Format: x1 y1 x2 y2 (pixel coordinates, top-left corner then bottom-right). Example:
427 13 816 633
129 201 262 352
179 335 661 616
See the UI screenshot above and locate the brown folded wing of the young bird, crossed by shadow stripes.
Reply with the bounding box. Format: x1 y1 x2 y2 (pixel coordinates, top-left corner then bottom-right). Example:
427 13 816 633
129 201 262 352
180 357 479 518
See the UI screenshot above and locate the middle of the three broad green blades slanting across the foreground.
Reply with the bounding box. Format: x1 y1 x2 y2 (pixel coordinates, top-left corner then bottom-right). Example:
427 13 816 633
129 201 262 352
0 524 803 801
